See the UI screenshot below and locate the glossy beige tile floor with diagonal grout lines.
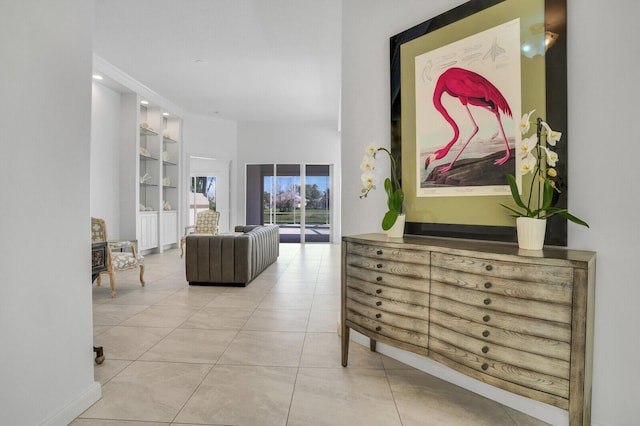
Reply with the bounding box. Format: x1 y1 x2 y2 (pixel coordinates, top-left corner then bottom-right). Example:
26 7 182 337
72 244 544 426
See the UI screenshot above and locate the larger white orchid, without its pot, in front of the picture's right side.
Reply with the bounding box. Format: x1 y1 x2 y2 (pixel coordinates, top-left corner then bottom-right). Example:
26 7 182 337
502 110 589 228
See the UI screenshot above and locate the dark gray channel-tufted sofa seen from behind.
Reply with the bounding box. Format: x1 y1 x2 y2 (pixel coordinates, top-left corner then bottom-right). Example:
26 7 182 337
185 225 280 286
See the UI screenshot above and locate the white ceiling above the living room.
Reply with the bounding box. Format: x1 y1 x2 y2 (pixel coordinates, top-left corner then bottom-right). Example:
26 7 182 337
93 0 342 122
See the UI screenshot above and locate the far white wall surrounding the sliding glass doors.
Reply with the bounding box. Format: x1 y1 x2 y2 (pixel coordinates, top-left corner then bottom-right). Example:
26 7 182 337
235 121 341 240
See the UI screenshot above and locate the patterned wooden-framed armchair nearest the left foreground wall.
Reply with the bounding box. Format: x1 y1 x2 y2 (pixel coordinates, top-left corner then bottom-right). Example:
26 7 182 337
91 217 144 297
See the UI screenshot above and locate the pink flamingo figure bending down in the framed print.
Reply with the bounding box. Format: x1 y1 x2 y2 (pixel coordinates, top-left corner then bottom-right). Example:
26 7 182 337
424 68 511 172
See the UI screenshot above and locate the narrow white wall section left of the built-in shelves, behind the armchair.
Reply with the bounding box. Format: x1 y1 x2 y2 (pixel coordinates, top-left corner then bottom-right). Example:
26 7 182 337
90 82 121 239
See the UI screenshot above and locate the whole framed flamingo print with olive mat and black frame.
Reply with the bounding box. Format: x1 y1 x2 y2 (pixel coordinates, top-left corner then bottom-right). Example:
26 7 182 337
390 0 568 245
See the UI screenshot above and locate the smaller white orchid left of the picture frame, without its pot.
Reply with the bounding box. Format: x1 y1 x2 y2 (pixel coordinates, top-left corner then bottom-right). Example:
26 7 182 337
360 145 404 231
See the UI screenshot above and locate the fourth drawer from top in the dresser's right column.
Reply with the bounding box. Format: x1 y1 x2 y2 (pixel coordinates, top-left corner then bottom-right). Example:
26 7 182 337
429 295 571 343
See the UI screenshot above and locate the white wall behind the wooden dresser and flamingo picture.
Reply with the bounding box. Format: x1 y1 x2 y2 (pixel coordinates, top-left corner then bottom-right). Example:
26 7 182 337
342 0 640 426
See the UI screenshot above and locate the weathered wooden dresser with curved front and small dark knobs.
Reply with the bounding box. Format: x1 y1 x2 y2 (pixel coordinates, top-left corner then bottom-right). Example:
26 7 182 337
342 234 595 426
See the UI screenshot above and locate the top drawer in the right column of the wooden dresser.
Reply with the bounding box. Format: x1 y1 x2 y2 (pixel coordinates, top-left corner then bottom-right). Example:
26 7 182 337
431 252 573 292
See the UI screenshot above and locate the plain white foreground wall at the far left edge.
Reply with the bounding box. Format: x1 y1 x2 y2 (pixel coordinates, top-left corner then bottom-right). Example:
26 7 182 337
0 0 100 425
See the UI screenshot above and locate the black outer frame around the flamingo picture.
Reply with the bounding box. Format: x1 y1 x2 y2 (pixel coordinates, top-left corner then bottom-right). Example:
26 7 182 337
390 0 569 246
